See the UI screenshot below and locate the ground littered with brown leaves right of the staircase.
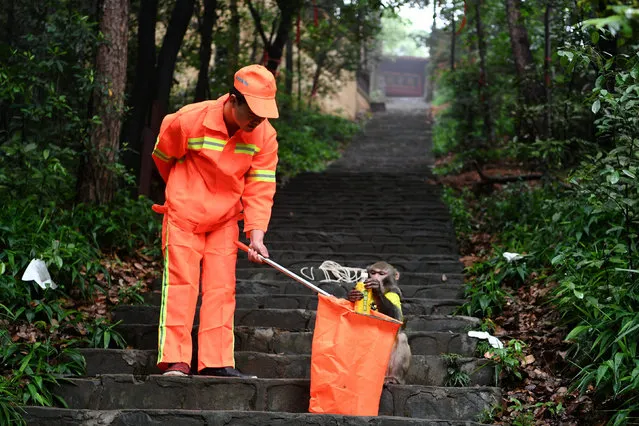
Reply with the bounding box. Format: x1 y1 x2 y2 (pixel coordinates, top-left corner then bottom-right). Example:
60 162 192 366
437 161 607 426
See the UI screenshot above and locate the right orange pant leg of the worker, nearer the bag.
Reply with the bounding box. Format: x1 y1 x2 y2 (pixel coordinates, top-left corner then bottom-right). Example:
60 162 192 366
198 220 239 371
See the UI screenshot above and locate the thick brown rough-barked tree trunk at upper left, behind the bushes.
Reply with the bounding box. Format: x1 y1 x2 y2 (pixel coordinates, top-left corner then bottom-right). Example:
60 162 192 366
78 0 129 203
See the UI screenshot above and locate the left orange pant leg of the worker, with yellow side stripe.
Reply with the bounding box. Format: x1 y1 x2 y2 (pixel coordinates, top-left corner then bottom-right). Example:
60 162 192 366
157 215 204 370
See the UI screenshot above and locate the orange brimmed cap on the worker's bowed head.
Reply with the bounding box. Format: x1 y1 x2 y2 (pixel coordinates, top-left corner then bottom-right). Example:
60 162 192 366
233 65 280 118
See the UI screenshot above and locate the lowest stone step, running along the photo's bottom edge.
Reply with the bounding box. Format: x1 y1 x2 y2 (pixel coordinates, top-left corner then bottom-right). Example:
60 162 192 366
24 407 480 426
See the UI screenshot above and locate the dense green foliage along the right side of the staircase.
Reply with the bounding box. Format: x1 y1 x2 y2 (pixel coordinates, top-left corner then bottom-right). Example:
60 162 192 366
432 1 639 425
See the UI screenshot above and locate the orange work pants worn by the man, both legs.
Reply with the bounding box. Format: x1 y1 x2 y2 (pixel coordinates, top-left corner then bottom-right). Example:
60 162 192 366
158 214 239 371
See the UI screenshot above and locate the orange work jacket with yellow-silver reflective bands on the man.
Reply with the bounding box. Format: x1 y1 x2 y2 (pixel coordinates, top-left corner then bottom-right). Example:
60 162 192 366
153 94 277 234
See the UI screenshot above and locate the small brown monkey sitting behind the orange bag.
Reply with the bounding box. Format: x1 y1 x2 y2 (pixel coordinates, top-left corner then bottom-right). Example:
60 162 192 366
348 262 411 385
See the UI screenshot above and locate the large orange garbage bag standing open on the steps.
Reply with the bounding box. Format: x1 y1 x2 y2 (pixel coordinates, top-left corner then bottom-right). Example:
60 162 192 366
309 294 401 416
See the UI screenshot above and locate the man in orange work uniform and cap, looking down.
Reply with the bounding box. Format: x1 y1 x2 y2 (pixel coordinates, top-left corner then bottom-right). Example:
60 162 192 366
153 65 279 377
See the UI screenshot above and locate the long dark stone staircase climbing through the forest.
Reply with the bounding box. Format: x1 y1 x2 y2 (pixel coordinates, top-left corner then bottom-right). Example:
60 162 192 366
26 101 500 426
